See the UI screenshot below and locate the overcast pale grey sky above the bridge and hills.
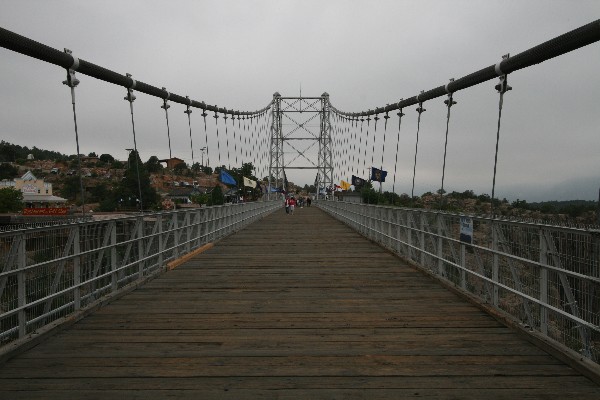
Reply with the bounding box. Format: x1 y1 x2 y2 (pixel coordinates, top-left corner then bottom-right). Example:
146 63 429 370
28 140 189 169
0 0 600 201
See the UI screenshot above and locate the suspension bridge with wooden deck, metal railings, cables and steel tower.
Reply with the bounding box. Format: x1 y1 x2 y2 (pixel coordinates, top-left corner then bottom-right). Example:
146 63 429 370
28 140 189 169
0 21 600 399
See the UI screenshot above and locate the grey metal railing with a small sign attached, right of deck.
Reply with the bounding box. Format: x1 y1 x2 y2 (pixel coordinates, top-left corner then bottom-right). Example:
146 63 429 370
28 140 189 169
317 201 600 363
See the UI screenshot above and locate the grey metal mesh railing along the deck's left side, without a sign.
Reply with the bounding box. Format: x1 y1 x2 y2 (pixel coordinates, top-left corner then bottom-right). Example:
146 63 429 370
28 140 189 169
0 201 280 348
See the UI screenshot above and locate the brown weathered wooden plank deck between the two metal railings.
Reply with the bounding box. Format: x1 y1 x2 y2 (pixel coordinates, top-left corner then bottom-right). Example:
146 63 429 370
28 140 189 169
0 207 600 400
